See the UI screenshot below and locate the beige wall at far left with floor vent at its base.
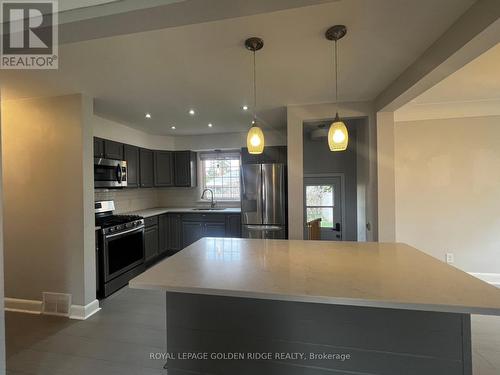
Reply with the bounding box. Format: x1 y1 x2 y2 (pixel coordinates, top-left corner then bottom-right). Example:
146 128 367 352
2 95 95 305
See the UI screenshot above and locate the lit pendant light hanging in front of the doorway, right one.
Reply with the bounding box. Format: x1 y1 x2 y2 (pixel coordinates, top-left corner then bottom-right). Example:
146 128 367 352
325 25 349 151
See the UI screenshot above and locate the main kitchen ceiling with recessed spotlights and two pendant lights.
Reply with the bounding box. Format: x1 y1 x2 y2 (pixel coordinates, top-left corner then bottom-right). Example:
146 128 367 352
0 0 474 135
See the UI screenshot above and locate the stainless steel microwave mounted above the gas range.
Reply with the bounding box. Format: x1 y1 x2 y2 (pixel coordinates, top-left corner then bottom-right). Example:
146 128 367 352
94 158 127 189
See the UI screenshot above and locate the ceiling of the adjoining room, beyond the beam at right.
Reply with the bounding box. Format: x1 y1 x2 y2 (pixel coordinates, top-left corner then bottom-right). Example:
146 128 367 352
396 43 500 121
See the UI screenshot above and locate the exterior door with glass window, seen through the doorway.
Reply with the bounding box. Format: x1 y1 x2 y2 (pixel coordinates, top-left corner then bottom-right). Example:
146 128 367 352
304 176 343 241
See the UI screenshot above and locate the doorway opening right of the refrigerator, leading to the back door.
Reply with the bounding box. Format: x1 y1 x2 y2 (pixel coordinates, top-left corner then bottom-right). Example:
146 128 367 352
303 117 369 241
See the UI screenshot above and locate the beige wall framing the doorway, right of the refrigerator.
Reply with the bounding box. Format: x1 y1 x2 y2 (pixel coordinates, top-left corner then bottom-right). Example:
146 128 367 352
287 103 377 241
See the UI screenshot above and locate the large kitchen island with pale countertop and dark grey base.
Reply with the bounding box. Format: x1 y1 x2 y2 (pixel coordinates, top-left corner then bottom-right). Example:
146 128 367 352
130 238 500 375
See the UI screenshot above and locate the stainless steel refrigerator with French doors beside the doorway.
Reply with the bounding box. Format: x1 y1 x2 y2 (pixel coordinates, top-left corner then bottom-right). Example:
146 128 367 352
241 164 287 239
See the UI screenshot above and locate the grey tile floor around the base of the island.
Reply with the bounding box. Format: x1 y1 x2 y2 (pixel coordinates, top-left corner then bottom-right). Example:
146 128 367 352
6 288 500 375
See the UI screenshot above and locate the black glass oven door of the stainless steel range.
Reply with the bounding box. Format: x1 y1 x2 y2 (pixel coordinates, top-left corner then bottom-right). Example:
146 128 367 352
101 226 144 283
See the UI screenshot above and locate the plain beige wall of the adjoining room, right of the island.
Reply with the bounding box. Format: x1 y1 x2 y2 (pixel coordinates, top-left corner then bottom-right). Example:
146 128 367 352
395 116 500 273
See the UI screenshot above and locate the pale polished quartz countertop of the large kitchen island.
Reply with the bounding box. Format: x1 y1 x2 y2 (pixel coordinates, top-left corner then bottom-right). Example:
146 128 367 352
130 238 500 315
